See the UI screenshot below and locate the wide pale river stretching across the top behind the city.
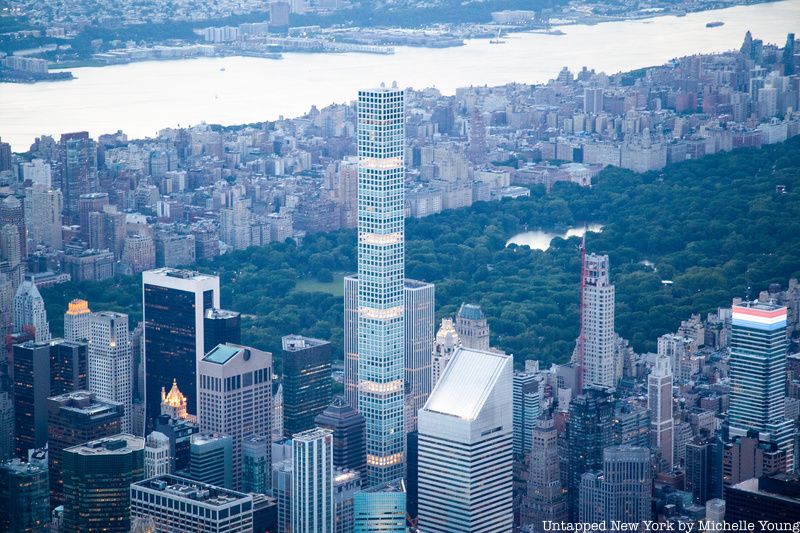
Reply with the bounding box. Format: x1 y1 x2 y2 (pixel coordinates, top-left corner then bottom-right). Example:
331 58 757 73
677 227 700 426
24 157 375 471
0 0 800 151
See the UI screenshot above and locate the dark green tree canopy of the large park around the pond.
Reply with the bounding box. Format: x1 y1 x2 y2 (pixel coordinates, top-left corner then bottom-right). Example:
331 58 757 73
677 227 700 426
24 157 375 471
42 137 800 365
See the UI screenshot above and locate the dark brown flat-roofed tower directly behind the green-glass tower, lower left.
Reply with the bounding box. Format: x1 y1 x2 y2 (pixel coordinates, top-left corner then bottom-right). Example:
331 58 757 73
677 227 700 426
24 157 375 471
47 390 125 507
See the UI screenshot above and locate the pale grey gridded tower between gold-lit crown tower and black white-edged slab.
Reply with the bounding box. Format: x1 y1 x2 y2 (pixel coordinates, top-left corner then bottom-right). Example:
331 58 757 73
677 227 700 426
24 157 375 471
89 311 133 433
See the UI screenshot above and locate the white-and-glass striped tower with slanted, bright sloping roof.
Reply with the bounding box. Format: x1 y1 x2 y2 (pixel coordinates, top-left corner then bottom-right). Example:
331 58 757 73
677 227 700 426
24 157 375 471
419 348 514 533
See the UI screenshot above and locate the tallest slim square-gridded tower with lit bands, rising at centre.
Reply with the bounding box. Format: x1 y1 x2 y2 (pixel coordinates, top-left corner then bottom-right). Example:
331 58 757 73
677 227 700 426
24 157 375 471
358 84 405 485
